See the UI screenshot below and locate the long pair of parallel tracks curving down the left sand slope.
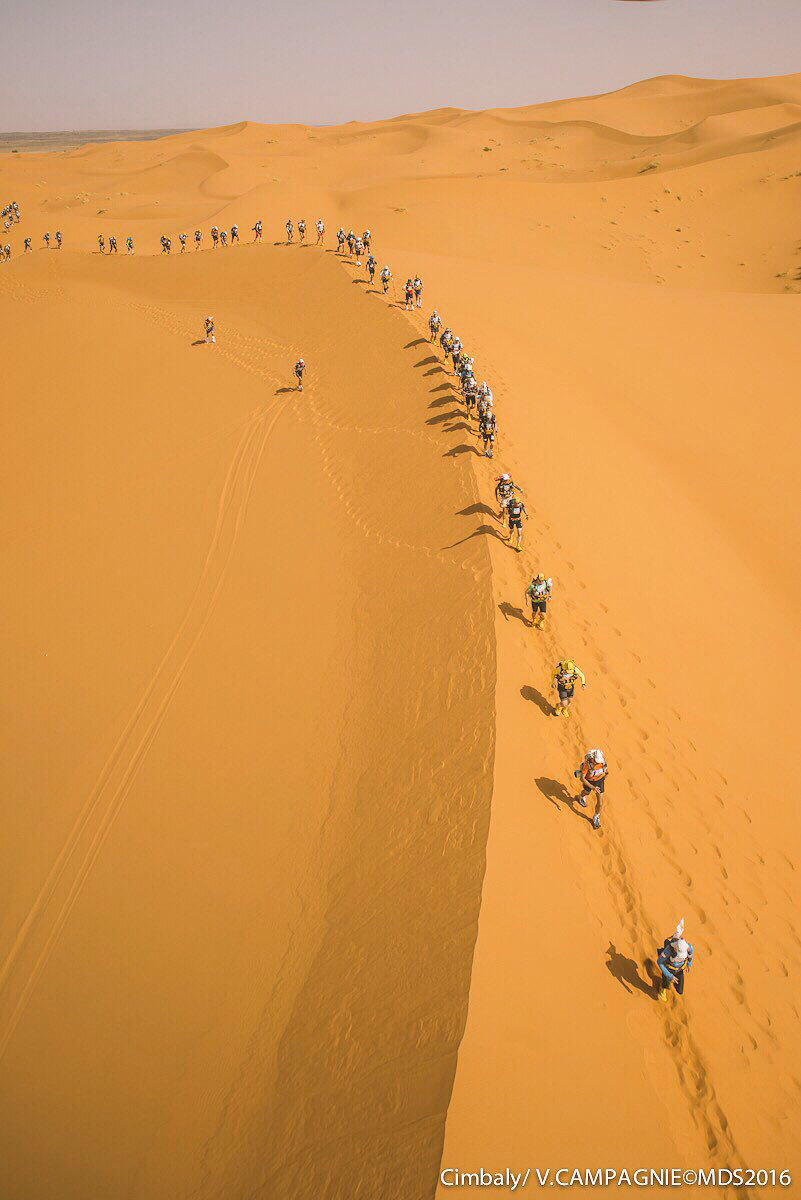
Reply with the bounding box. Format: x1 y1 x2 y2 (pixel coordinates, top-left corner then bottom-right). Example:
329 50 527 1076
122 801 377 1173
0 306 291 1058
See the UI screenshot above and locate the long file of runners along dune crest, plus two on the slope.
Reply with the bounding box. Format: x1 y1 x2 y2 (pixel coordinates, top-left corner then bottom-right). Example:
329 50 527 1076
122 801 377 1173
0 203 694 1001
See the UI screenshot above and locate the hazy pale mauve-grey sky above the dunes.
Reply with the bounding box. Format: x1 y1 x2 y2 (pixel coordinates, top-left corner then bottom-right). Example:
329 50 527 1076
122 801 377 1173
0 0 801 131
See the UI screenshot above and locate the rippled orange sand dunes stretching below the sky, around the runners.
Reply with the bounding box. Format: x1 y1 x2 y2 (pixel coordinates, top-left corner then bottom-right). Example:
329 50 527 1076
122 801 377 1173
0 76 801 1200
